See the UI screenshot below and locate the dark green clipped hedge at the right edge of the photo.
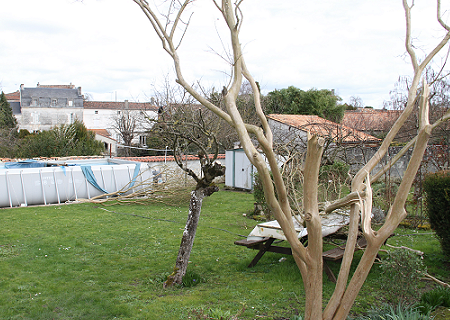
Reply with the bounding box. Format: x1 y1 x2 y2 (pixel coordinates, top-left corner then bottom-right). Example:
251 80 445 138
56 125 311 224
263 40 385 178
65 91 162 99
423 171 450 257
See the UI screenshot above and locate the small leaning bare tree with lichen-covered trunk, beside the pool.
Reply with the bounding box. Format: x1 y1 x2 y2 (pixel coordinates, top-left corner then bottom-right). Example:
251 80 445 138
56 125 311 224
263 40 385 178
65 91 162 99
153 104 225 287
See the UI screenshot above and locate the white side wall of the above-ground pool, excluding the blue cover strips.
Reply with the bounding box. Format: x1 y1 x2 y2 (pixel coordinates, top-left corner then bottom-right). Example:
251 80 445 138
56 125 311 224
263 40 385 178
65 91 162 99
0 163 153 207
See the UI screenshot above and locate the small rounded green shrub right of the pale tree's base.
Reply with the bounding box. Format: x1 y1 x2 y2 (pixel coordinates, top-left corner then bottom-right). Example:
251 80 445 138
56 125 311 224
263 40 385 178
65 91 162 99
381 249 426 303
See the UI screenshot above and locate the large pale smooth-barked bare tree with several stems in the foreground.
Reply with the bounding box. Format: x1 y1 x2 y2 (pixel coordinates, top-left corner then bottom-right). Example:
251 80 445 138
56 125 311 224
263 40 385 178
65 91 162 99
133 0 450 320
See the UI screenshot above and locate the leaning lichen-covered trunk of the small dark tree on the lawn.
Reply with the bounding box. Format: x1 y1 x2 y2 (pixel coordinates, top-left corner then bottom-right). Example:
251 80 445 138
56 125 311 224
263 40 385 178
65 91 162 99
164 186 219 288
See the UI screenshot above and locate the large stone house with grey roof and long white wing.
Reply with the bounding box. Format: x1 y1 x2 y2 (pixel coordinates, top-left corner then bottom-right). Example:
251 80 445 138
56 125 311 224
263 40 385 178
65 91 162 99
6 83 158 155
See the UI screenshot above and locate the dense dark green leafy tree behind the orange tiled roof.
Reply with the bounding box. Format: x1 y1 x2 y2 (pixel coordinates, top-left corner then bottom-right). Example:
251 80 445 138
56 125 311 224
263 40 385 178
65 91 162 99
265 86 345 122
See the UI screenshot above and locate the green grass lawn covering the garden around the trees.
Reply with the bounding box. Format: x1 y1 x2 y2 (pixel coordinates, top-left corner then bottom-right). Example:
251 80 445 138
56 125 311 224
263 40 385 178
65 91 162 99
0 191 449 319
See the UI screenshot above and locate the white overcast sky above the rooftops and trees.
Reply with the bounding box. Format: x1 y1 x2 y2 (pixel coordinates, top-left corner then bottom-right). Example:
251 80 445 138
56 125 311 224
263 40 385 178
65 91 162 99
0 0 450 108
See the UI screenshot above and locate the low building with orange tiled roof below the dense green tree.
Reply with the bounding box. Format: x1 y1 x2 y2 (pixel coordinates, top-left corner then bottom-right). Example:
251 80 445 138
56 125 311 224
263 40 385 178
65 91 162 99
267 114 381 146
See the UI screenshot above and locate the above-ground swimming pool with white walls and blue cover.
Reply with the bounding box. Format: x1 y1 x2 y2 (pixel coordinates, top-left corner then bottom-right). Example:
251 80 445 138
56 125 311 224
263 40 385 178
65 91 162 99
0 158 153 207
